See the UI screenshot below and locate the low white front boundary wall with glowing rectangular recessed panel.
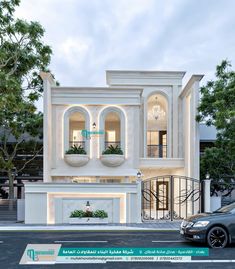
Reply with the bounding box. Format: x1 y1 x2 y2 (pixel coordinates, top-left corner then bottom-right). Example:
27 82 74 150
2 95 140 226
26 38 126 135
25 182 141 224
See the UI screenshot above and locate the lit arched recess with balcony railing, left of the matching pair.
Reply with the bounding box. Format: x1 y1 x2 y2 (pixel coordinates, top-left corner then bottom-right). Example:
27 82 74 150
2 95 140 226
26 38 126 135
64 106 90 155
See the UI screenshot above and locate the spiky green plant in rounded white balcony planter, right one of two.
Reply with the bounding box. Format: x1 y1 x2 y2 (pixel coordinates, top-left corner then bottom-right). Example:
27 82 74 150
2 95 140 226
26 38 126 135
100 145 125 167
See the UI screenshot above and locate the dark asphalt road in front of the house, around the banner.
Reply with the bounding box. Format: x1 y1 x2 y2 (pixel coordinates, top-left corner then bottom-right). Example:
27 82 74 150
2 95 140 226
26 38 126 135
0 231 235 269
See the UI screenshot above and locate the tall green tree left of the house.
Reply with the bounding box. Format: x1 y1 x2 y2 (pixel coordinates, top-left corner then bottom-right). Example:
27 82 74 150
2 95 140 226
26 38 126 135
0 0 52 199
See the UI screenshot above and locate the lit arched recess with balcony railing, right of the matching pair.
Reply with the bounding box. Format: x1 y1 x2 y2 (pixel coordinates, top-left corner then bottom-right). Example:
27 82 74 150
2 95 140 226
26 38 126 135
99 107 126 155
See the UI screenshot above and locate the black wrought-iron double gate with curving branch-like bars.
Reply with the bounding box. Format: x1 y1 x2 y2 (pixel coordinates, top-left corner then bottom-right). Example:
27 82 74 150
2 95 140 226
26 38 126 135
142 176 201 222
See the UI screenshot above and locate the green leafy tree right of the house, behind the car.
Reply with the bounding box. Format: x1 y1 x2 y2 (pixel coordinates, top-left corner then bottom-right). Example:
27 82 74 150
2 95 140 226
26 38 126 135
197 60 235 180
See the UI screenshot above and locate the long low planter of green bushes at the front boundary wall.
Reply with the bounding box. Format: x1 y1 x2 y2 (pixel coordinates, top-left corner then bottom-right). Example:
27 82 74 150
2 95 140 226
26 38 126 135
69 210 108 224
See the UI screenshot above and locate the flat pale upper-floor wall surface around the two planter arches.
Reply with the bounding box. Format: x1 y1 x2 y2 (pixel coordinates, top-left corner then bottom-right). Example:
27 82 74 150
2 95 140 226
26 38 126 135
51 105 139 176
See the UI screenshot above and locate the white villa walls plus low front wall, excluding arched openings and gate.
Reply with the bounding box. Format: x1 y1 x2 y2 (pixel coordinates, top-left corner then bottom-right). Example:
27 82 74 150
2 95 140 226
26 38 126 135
25 71 202 224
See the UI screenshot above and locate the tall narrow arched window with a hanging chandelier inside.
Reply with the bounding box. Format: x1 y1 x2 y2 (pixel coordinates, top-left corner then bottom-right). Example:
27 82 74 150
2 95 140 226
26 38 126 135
147 94 168 158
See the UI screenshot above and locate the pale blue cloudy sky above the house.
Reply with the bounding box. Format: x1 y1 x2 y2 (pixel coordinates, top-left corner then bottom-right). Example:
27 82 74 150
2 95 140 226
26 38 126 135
16 0 235 110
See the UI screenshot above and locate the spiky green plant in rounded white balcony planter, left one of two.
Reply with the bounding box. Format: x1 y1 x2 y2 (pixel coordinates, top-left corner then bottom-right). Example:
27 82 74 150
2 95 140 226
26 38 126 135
64 145 89 167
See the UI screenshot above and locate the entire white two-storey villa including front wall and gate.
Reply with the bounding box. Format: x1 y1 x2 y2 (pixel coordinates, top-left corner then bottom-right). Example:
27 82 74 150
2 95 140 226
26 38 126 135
25 71 203 224
